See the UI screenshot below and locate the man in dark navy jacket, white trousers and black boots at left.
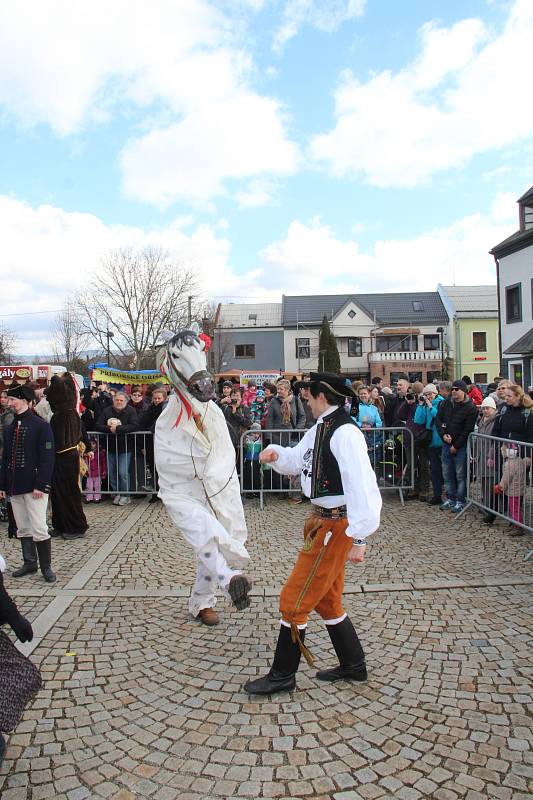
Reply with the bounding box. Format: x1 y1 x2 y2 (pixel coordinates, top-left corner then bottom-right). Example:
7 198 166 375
0 385 56 583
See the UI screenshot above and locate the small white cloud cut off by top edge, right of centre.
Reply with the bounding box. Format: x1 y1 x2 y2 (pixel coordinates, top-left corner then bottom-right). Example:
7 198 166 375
273 0 366 50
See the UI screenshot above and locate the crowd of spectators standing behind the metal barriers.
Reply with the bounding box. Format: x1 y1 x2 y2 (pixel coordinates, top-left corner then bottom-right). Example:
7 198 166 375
0 375 533 536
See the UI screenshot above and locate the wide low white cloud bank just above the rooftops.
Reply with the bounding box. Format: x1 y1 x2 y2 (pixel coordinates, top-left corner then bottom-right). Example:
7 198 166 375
0 194 517 353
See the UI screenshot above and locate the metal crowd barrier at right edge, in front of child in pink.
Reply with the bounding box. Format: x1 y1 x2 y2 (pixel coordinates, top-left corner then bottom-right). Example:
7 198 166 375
458 433 533 559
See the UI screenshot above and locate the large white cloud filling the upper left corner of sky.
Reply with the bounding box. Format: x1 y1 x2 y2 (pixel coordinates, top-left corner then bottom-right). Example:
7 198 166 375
0 0 298 206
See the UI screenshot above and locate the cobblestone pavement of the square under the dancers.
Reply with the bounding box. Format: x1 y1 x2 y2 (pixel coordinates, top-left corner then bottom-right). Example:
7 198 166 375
0 497 533 800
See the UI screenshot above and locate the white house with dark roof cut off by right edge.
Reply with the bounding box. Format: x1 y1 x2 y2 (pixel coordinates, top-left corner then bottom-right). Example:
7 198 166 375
490 186 533 389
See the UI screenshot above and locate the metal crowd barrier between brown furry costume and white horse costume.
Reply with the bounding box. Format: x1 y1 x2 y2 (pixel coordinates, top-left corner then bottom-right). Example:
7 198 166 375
82 431 158 504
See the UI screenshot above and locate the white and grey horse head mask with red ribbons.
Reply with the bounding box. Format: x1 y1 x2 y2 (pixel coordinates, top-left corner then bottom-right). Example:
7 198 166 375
162 323 215 403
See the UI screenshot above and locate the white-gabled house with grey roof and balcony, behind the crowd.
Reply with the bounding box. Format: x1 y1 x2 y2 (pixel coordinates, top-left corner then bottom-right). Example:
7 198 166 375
281 292 449 383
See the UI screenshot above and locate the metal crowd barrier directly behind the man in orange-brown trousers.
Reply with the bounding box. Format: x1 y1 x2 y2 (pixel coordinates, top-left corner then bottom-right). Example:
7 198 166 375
238 427 415 509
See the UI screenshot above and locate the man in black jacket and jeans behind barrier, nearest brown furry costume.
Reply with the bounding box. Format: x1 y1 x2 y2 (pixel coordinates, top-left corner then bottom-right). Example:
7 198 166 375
95 392 139 506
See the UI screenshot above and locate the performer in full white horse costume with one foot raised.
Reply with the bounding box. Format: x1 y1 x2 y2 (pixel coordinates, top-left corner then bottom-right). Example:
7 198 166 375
154 326 251 617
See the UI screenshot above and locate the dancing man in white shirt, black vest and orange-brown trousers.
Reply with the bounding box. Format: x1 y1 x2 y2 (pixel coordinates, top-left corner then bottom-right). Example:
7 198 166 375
244 372 381 694
